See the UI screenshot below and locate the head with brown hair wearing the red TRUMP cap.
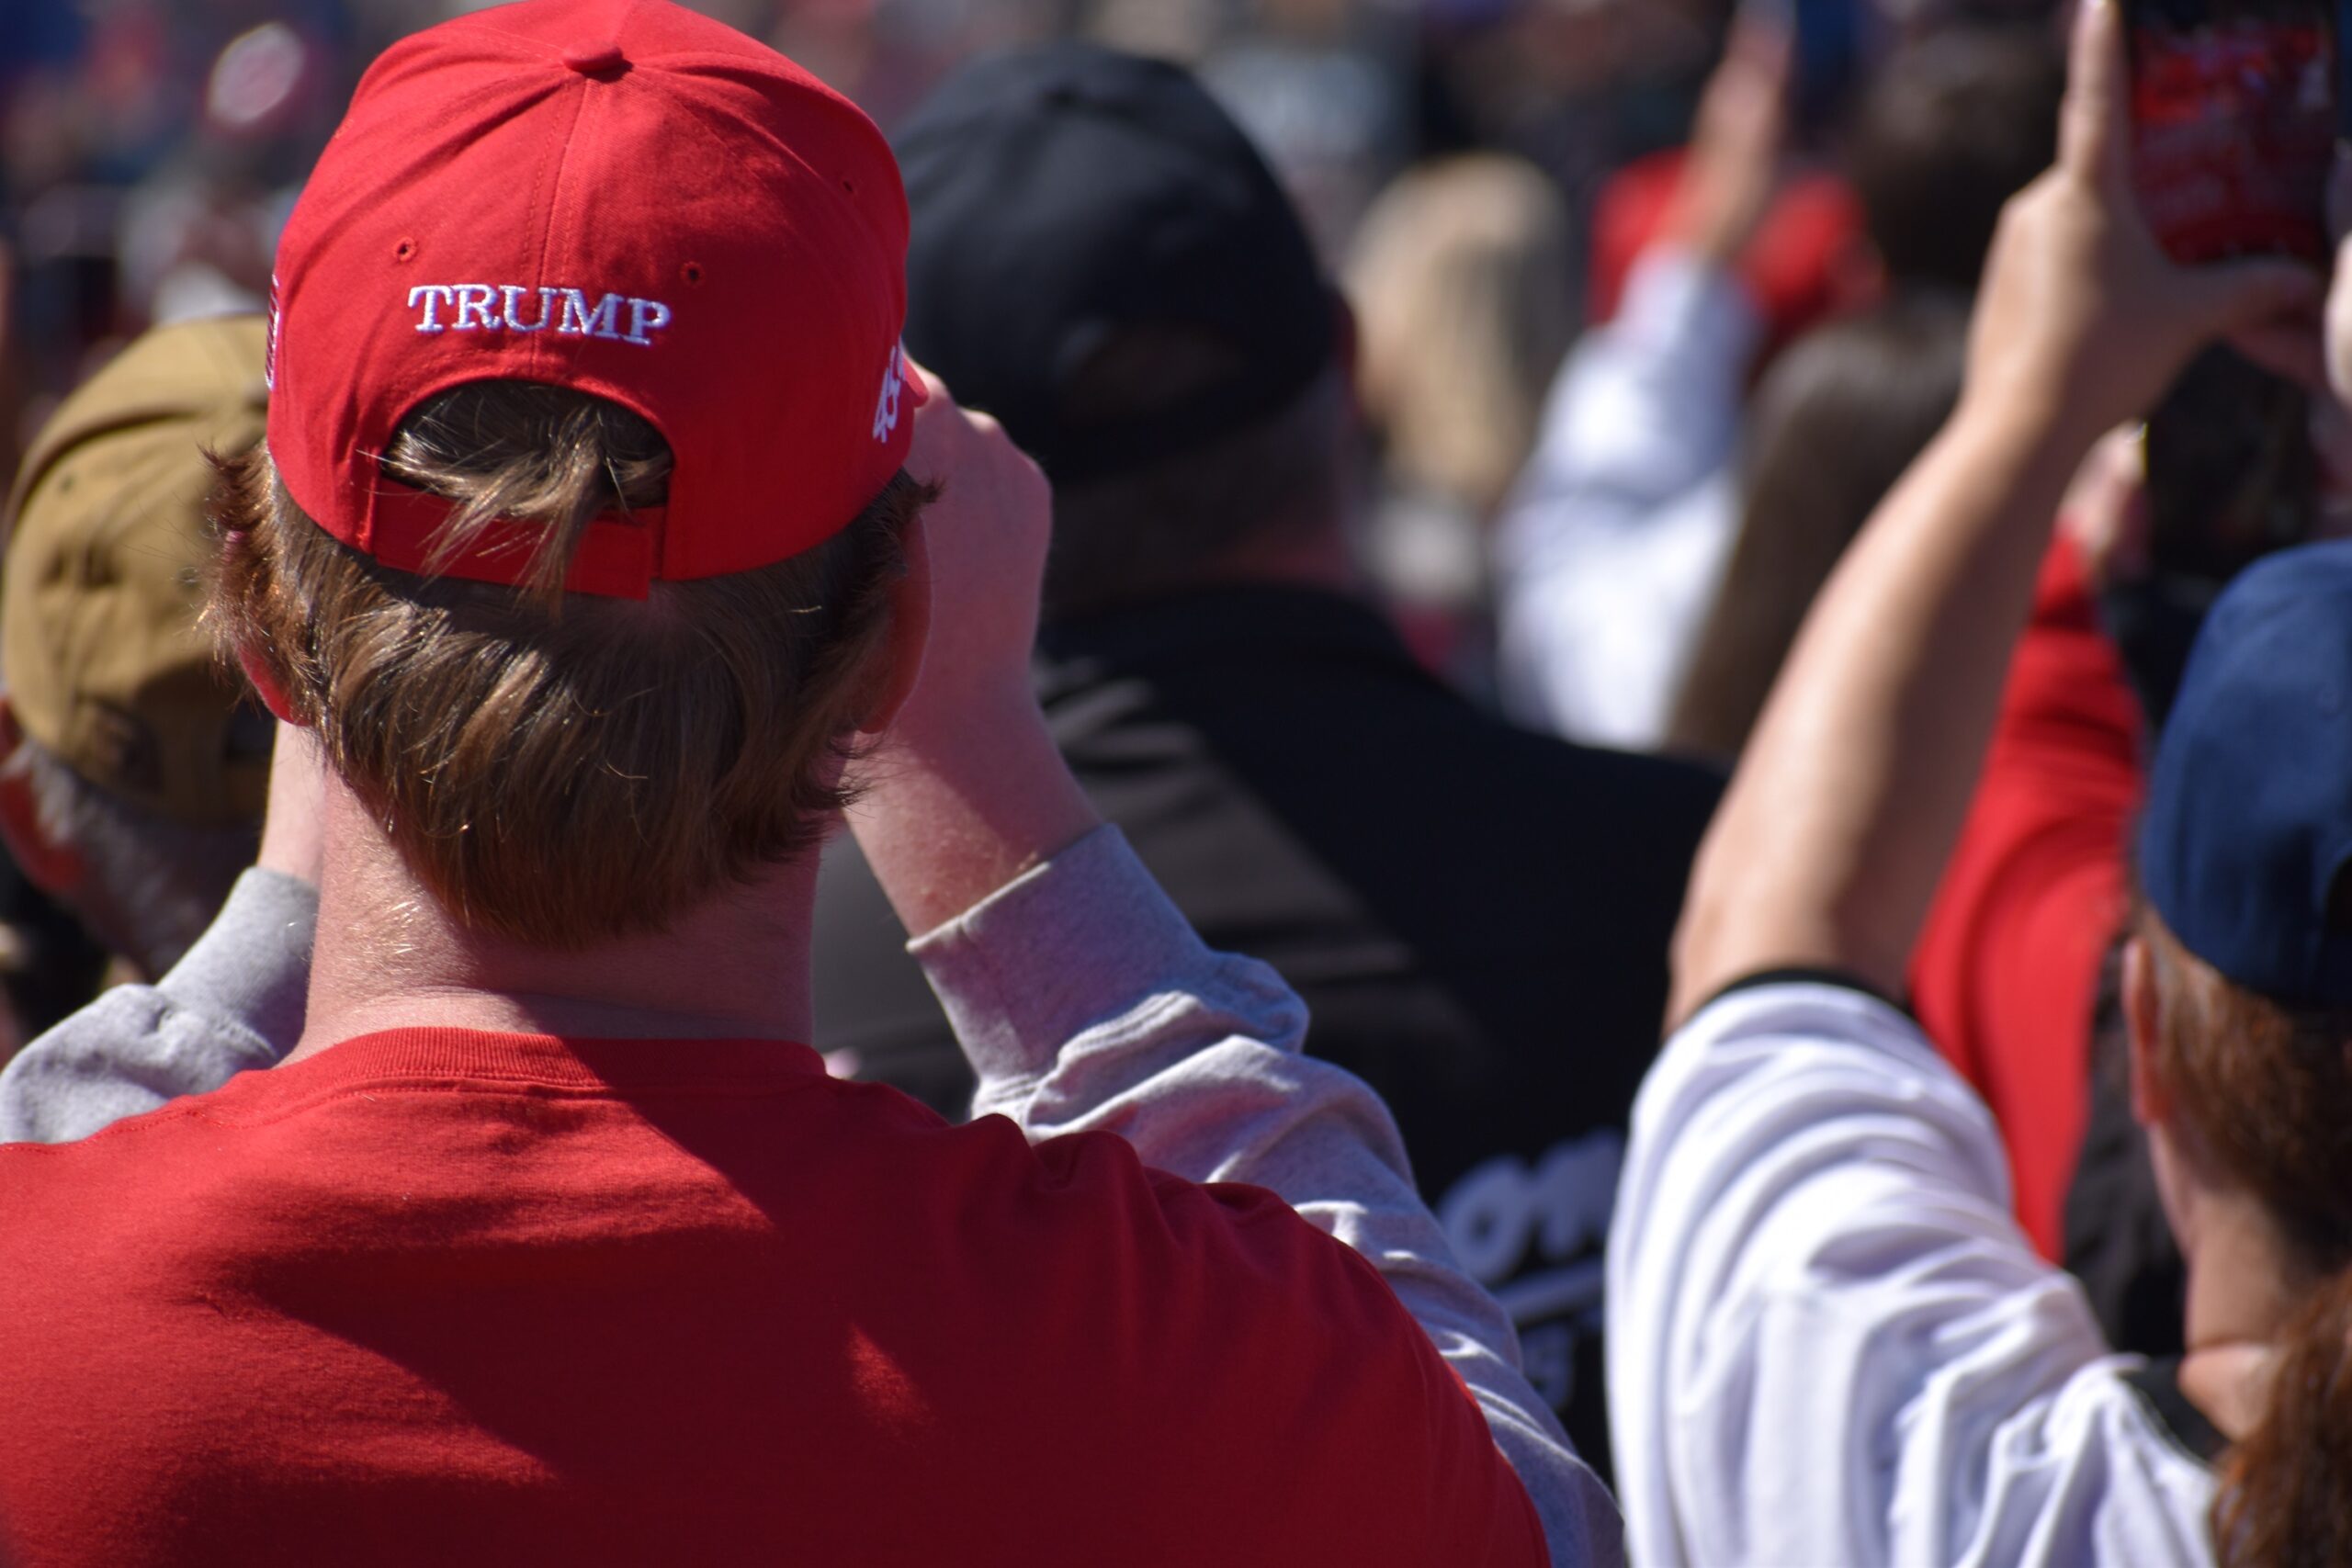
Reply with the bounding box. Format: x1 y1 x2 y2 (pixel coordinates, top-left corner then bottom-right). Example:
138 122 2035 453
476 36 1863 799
219 0 924 947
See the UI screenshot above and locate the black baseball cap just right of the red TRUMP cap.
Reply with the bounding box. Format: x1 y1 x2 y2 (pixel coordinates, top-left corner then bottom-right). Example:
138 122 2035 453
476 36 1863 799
891 42 1336 479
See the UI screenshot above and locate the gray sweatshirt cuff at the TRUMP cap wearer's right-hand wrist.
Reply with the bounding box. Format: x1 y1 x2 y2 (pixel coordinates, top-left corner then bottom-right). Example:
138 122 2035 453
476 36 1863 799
908 825 1214 1081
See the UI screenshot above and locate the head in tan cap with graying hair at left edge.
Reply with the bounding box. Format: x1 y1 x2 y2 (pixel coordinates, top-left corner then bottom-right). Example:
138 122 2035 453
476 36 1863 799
0 317 270 974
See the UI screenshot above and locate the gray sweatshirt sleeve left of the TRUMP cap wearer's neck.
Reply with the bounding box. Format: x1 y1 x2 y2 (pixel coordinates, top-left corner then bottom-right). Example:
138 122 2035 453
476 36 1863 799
0 870 318 1143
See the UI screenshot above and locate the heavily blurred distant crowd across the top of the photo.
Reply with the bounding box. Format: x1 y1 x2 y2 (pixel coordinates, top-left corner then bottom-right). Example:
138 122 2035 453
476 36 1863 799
0 0 2058 1043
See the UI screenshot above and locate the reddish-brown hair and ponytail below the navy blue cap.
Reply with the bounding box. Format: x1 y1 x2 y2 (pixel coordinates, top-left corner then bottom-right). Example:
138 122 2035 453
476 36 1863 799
2138 908 2352 1568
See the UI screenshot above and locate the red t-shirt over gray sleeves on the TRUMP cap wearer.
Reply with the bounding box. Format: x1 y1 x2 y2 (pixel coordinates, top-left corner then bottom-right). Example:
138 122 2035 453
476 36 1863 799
0 1030 1543 1568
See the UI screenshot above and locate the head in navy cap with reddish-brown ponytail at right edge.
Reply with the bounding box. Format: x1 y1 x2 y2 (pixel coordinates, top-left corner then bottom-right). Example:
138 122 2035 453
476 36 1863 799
2124 541 2352 1563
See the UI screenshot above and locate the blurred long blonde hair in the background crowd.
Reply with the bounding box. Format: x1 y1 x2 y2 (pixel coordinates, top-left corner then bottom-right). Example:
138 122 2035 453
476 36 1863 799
1348 152 1576 514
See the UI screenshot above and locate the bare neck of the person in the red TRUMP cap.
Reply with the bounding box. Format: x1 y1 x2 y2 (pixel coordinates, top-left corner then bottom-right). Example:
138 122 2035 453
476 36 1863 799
287 783 816 1060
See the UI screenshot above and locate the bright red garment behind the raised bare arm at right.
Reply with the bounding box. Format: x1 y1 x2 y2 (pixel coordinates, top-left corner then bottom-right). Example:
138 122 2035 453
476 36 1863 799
1912 538 2141 1258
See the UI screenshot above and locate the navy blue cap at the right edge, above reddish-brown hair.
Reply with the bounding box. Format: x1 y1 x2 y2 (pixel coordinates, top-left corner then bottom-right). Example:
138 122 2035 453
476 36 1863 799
2141 541 2352 1006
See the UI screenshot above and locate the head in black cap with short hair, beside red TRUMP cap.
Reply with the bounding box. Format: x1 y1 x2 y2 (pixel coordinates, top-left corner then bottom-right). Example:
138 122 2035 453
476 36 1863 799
896 42 1348 614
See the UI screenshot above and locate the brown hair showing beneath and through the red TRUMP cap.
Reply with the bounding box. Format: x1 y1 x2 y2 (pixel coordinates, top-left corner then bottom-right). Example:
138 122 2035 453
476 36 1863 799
214 381 936 947
